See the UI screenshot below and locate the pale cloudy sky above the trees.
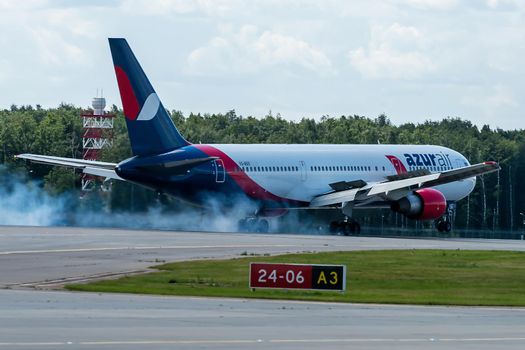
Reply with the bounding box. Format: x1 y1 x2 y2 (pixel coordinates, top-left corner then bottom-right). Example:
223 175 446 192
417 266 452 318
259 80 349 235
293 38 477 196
0 0 525 129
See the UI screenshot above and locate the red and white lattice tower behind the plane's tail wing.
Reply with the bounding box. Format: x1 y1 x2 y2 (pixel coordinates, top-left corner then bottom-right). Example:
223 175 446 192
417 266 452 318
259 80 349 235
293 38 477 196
82 97 115 192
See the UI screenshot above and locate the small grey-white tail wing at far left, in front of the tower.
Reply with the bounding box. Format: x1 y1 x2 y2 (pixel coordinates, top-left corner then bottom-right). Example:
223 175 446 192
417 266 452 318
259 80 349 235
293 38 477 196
15 153 124 180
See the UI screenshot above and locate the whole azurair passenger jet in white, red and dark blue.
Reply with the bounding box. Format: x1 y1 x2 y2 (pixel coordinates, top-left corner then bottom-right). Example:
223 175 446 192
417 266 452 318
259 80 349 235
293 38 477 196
17 38 500 235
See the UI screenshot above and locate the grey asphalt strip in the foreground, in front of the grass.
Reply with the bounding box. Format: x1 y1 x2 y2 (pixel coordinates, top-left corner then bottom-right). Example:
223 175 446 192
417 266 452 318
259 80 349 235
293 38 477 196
0 290 525 349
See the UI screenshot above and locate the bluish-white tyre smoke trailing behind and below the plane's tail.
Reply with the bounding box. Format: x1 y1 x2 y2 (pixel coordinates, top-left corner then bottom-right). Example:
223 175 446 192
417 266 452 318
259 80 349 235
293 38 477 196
0 166 266 232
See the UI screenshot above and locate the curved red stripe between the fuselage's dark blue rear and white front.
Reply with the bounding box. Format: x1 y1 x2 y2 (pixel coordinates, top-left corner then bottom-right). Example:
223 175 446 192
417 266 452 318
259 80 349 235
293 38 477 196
193 145 299 204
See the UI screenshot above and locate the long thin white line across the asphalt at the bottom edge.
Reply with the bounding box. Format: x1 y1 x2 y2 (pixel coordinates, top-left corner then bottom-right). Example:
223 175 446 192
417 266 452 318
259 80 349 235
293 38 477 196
0 337 525 347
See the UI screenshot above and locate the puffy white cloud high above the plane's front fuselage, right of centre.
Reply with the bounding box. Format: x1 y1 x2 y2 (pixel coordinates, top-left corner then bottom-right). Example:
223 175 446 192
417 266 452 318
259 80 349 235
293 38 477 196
348 23 436 80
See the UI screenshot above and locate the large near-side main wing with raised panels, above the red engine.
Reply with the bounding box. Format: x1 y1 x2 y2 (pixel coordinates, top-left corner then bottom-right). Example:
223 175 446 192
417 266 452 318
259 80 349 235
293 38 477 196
310 162 500 207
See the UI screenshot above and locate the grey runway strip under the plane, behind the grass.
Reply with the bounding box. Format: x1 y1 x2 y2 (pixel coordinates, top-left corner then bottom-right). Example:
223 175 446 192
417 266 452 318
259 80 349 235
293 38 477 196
0 226 525 288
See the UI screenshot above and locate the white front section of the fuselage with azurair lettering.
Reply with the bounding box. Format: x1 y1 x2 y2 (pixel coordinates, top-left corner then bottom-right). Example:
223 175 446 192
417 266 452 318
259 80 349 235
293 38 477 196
210 144 475 202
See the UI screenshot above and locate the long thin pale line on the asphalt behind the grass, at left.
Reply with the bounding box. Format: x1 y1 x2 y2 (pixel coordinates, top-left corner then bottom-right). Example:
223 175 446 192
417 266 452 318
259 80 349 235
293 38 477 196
0 244 299 255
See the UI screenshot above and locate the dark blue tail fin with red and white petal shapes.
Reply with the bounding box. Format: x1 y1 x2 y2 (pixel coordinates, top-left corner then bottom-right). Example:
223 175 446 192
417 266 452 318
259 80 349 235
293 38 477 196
109 38 188 156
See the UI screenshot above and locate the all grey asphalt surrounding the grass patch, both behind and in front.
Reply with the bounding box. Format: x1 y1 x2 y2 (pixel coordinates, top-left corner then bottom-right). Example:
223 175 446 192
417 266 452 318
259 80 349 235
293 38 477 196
0 227 525 350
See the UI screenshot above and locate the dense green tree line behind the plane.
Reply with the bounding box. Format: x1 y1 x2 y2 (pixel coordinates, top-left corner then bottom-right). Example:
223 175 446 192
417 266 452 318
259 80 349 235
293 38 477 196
0 104 525 230
